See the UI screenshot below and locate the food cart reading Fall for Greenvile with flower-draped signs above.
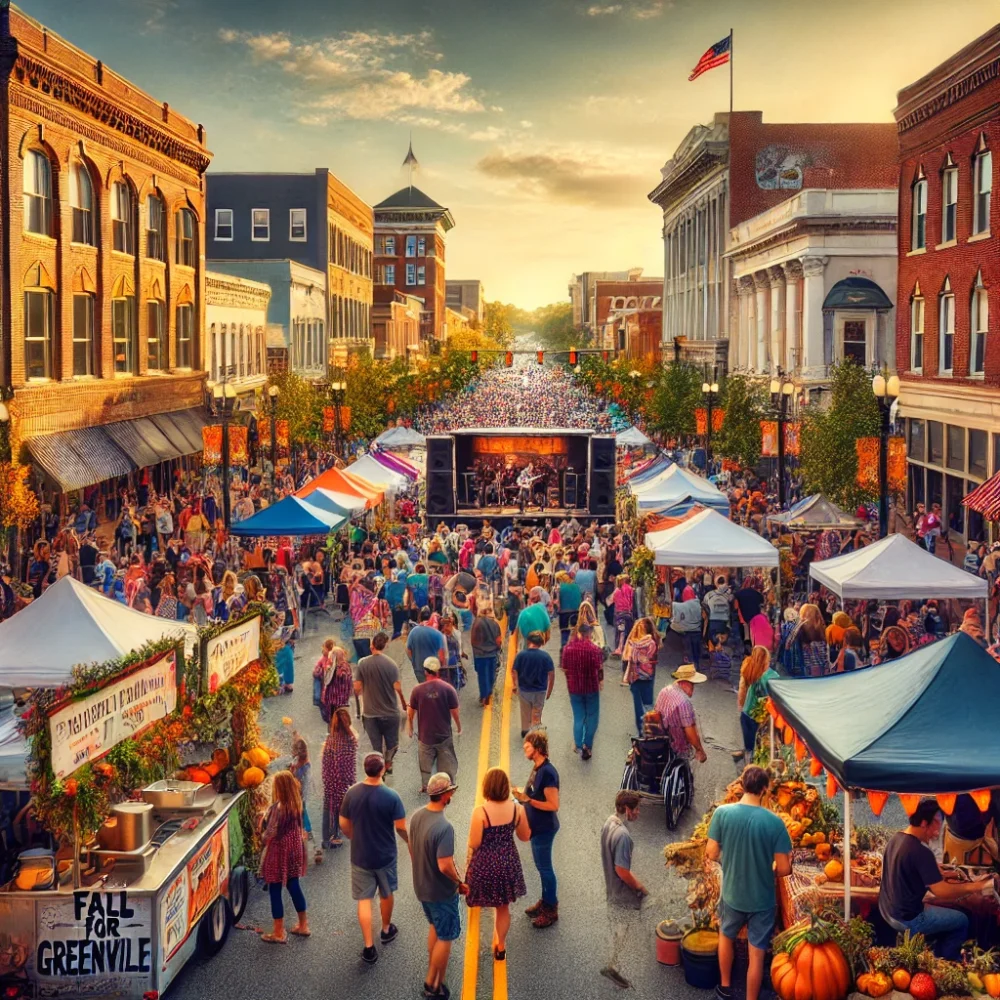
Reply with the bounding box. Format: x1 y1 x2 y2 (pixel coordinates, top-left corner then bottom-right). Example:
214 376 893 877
0 605 275 998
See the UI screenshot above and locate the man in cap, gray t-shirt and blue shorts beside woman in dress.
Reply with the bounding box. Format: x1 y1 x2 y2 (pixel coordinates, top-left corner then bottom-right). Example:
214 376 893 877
410 771 469 996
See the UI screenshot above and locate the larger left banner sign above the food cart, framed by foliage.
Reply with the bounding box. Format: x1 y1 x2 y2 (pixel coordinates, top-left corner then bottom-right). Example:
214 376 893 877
49 649 177 778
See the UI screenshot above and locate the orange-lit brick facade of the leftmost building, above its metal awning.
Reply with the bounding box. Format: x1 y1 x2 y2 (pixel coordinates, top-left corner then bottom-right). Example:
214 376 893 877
0 8 211 440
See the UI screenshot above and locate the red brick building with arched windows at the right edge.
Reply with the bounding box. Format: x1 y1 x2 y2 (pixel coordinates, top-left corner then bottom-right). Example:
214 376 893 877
895 25 1000 538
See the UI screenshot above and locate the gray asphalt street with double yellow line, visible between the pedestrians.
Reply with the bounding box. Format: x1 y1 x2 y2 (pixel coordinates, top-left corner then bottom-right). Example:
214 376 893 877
169 616 752 1000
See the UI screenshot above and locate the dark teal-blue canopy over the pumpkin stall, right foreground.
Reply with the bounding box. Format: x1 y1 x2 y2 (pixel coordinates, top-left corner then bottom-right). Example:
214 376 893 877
768 632 1000 794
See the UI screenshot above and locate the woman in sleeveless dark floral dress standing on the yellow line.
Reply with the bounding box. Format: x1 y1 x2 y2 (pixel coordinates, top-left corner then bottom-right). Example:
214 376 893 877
465 767 531 962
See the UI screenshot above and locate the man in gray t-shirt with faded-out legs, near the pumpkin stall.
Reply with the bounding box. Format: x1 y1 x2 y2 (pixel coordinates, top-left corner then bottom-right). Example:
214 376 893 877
601 791 648 989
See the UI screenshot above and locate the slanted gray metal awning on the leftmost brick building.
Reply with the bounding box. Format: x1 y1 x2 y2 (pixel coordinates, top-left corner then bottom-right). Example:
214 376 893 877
26 407 206 493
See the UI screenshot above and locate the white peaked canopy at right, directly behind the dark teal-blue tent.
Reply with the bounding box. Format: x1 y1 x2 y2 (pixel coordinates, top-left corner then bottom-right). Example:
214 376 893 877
809 535 987 601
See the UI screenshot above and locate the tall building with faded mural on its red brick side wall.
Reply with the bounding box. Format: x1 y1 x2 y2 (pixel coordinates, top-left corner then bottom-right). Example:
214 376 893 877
649 111 896 373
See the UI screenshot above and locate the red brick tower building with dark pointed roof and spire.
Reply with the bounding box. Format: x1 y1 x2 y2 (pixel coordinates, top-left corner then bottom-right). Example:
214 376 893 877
375 185 455 351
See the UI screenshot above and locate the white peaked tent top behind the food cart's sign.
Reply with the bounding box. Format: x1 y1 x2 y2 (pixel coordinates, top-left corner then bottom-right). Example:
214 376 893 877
0 576 198 688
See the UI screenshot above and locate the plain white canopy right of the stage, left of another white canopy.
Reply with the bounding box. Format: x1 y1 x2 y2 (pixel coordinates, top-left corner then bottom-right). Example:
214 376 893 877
645 510 778 567
